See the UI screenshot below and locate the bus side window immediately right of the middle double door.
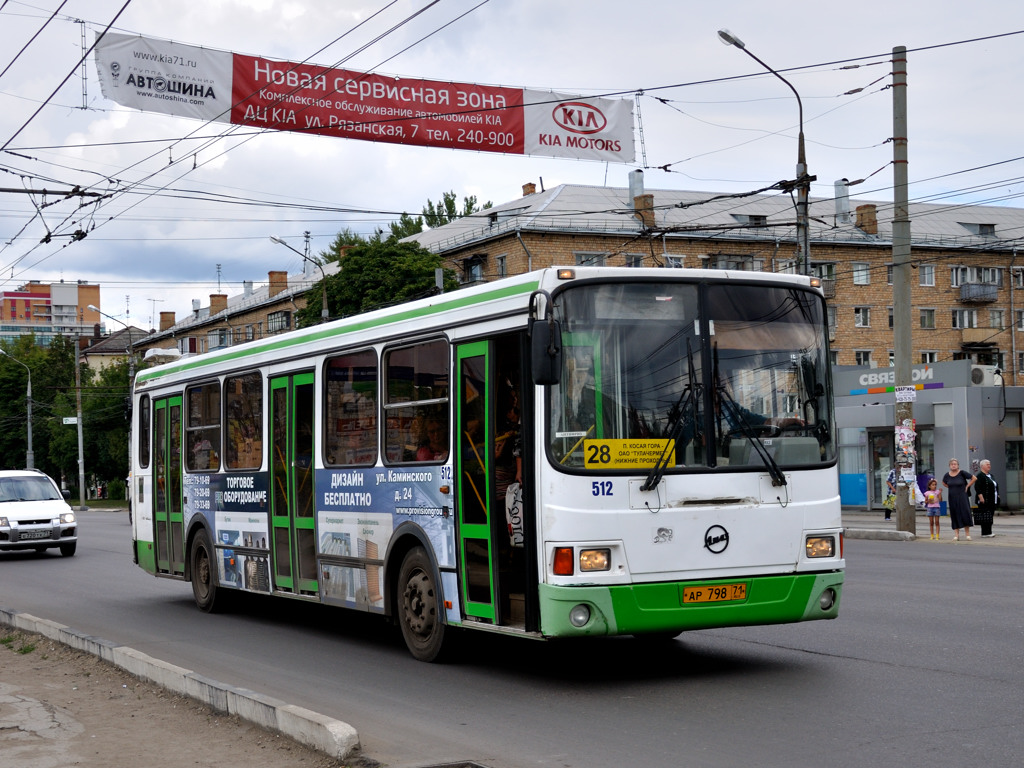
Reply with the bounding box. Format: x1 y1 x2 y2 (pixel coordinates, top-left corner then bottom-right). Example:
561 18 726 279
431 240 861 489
324 349 377 467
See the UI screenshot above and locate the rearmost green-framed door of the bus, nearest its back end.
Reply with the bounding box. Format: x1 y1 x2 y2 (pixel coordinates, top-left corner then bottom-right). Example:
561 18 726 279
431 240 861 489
152 395 185 575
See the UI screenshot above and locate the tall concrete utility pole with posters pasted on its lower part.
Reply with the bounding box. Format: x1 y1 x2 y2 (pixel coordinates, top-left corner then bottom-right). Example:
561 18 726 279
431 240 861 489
892 45 918 534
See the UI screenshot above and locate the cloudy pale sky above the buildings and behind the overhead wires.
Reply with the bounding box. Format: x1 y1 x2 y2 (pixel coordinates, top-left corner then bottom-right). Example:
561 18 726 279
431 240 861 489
0 0 1024 329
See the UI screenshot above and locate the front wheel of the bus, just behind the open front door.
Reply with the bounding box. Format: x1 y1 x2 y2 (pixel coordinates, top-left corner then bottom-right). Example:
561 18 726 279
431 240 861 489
398 547 445 662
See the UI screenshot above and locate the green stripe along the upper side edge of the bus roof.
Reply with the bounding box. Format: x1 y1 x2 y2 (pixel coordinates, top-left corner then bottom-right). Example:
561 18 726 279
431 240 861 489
136 281 540 383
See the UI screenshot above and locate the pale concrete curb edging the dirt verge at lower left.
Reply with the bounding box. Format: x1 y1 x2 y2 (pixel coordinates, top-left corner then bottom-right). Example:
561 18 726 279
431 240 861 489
0 606 359 760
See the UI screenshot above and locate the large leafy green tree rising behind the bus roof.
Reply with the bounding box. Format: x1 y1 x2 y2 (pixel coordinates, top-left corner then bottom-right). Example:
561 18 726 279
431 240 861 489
297 238 459 326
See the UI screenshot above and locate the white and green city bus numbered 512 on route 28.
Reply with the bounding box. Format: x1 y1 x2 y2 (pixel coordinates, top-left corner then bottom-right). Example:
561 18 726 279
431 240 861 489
132 267 845 660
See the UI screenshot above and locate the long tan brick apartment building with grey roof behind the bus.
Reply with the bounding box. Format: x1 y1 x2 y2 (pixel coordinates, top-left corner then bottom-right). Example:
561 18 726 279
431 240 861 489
409 171 1024 384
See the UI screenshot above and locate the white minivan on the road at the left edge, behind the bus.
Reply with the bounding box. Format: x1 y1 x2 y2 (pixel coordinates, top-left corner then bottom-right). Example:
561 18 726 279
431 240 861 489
0 469 78 557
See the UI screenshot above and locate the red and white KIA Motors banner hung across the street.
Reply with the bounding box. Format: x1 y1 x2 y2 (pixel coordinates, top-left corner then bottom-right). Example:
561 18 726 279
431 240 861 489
96 34 634 163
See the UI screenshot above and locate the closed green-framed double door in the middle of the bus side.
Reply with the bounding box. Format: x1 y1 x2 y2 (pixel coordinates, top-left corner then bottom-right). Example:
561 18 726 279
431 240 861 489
270 373 318 596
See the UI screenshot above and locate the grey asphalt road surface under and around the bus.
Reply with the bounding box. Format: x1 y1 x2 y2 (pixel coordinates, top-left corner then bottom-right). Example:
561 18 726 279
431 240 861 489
0 512 1024 768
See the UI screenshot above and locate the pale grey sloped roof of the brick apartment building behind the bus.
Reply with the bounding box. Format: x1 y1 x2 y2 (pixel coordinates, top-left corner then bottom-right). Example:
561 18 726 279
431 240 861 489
407 179 1024 253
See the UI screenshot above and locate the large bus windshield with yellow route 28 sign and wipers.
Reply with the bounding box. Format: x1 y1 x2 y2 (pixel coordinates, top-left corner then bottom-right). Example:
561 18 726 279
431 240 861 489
548 281 836 473
